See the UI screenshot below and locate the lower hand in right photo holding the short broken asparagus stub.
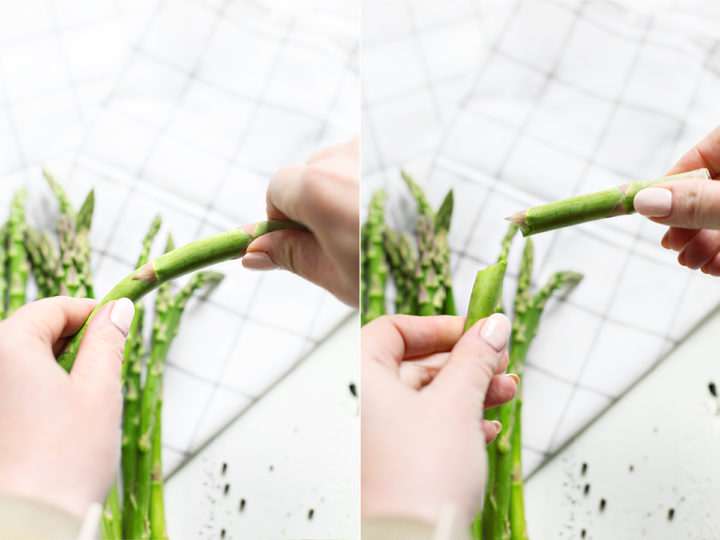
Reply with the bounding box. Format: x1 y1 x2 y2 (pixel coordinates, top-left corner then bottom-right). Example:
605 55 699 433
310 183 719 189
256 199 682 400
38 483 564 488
361 314 518 523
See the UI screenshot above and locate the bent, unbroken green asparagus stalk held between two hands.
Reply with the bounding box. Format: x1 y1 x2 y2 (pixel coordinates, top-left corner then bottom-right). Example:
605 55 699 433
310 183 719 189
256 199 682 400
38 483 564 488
58 220 307 371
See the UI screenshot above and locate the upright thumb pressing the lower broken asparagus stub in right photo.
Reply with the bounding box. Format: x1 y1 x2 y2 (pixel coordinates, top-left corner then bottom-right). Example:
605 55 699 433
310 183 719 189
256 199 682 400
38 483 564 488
430 313 511 408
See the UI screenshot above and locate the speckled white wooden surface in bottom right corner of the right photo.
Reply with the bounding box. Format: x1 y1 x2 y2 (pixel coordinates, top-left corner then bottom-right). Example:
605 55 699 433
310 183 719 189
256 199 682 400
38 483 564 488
526 306 720 540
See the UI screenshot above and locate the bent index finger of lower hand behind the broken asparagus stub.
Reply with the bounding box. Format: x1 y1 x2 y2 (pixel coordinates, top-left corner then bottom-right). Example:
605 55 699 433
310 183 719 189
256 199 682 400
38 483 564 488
362 315 465 370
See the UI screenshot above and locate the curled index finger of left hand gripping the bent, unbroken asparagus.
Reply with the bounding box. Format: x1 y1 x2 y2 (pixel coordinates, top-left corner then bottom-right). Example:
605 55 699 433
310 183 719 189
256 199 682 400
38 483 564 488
2 296 97 350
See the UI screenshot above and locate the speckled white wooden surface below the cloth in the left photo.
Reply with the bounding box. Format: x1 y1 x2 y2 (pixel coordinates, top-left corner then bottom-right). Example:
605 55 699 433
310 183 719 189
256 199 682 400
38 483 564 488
166 316 360 540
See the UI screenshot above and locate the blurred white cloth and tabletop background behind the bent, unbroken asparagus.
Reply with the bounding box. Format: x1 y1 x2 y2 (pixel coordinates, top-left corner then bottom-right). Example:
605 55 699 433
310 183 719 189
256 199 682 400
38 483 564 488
0 0 359 538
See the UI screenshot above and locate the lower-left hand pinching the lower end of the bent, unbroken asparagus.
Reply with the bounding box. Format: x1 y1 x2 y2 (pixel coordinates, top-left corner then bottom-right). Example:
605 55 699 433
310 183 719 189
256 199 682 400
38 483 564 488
0 297 134 518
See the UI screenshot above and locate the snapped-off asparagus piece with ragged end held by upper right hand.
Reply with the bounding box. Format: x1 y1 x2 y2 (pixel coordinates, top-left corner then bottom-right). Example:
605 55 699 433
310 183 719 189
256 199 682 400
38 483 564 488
505 169 710 236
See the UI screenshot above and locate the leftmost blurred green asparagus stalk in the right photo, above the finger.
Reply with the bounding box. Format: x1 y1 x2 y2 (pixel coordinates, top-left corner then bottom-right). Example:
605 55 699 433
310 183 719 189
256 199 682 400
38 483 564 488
365 190 388 322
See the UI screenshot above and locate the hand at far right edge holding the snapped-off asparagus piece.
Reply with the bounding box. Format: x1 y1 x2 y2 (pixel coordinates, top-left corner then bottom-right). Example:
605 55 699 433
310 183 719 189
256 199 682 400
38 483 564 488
634 126 720 276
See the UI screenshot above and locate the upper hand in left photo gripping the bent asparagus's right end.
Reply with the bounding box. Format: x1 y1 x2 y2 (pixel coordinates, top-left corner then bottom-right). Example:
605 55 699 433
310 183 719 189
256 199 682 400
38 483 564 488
242 138 359 307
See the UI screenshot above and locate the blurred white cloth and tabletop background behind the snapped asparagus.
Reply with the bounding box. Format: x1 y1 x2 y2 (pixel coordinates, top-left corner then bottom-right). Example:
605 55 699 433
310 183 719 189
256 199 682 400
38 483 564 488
362 0 720 538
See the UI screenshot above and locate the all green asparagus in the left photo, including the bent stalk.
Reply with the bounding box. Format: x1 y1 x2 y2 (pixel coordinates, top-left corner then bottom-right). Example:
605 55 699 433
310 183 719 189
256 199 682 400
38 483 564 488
0 173 304 540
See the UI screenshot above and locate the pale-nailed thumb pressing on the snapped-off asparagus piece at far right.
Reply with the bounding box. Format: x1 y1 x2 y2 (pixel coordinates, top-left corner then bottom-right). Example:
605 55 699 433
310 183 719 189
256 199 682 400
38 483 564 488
633 178 720 229
